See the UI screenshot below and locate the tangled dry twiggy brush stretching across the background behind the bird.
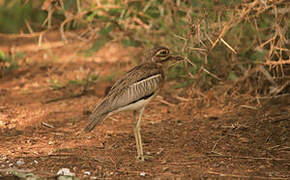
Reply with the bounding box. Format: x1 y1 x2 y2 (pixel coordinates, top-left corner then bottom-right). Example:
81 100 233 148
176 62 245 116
1 0 290 107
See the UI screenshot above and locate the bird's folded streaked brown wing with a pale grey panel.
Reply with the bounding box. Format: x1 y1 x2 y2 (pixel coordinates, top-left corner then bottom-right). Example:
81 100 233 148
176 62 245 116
96 64 164 112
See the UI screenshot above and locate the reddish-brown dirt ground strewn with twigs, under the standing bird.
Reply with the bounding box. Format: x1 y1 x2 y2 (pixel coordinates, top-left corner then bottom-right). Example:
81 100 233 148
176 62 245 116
0 33 290 179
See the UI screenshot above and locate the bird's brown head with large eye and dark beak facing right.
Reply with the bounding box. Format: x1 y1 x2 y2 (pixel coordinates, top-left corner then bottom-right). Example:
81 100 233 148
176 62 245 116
143 46 182 63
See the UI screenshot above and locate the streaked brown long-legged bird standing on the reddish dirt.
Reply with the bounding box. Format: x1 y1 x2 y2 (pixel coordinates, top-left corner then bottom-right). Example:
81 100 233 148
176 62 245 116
84 46 182 161
